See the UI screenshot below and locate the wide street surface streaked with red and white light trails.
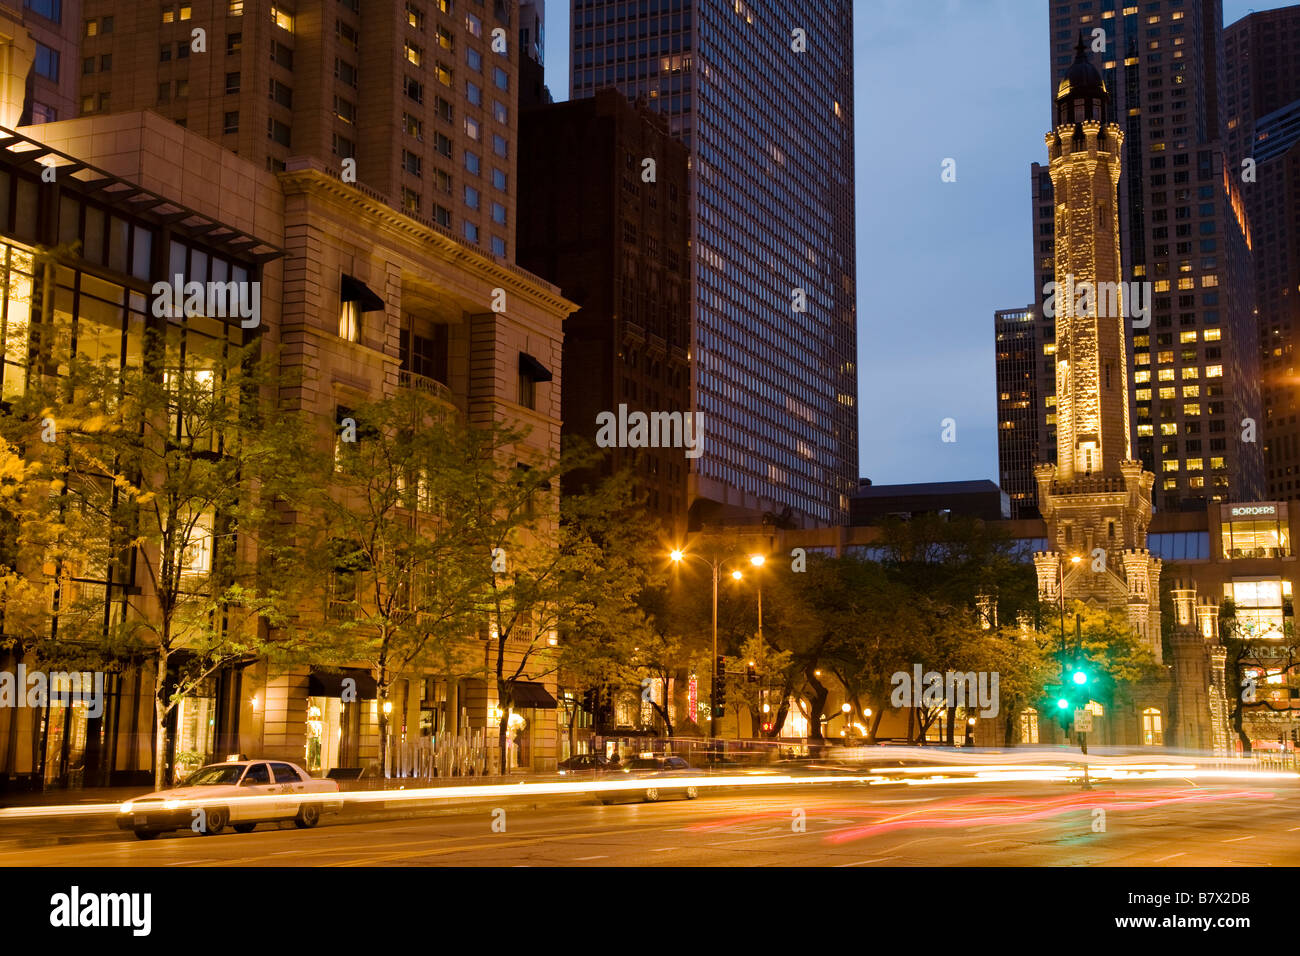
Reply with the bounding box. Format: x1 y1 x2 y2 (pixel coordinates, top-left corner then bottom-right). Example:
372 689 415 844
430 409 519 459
0 777 1300 868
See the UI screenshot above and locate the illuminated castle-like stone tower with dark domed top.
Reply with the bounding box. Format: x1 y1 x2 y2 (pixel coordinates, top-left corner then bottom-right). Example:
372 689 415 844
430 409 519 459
1034 38 1161 659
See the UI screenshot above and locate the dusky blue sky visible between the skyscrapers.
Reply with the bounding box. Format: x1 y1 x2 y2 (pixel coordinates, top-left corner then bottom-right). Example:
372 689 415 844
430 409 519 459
546 0 1288 484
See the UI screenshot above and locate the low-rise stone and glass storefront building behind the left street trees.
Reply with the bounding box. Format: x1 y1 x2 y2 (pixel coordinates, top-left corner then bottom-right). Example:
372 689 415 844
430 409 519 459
0 112 573 787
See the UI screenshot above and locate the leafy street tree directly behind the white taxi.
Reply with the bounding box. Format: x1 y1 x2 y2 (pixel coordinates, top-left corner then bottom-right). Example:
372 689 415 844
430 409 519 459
17 333 312 787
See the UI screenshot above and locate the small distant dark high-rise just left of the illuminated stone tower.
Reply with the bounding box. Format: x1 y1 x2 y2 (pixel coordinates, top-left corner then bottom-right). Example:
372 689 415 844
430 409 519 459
993 306 1056 518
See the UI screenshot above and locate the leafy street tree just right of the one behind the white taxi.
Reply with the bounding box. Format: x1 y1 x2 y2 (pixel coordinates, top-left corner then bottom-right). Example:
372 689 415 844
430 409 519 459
300 389 490 769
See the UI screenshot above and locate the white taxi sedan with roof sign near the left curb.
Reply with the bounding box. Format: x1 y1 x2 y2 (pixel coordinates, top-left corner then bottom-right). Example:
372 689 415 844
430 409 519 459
117 760 343 840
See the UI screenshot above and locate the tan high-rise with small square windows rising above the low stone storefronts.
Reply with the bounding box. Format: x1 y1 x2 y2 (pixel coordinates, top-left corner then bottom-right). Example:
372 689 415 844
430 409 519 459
77 0 521 259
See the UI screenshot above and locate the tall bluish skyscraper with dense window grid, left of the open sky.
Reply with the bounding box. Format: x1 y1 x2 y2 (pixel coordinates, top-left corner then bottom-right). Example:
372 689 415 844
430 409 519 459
569 0 858 525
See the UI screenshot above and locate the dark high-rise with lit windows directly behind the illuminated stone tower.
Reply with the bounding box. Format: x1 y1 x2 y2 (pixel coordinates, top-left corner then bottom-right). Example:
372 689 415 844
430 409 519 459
1032 0 1262 510
